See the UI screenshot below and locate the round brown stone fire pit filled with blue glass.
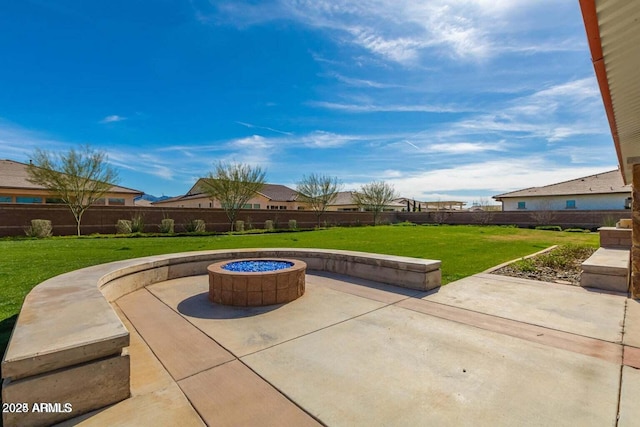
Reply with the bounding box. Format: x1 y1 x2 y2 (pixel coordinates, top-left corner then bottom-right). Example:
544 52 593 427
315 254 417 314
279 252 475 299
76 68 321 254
207 258 307 307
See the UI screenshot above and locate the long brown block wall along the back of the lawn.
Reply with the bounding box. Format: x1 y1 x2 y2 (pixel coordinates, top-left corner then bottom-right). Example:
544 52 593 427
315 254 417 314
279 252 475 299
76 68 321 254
0 205 631 236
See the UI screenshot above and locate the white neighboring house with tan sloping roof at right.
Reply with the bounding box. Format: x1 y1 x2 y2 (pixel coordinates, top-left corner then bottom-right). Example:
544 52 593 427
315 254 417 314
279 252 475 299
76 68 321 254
493 170 631 211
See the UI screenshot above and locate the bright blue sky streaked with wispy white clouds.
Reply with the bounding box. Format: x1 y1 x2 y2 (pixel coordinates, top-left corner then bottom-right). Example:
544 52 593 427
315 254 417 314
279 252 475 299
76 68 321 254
0 0 617 203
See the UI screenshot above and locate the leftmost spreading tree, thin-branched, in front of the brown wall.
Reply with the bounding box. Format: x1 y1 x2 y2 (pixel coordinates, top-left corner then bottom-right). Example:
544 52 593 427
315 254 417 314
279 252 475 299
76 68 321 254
27 145 118 236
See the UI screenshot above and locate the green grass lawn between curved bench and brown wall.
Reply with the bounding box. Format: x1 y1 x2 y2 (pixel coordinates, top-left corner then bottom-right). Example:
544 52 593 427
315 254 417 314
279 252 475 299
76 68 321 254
0 225 598 354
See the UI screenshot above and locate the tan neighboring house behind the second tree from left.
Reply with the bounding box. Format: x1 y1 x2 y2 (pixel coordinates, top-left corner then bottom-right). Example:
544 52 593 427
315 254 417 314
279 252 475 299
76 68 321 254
152 178 305 210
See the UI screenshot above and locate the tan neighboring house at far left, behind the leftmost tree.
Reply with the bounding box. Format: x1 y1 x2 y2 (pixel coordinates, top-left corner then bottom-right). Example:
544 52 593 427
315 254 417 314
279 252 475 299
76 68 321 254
0 160 144 206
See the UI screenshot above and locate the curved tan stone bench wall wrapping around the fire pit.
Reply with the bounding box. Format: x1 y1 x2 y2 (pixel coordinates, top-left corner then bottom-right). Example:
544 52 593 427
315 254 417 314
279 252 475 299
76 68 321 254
2 249 441 426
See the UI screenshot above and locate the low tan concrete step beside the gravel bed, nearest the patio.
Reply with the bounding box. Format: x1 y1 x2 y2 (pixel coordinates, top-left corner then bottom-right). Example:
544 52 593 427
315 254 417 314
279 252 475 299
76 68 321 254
580 248 630 292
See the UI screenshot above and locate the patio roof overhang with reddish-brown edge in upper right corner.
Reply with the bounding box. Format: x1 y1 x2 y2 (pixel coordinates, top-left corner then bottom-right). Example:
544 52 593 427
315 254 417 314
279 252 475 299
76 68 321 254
580 0 640 183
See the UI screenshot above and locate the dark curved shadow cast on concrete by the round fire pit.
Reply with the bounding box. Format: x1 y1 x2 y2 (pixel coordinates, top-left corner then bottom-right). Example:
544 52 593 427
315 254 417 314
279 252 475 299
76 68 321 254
177 292 284 319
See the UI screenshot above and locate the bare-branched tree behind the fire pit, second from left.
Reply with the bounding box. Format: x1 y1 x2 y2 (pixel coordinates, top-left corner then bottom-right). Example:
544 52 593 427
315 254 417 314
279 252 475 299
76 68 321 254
200 162 266 231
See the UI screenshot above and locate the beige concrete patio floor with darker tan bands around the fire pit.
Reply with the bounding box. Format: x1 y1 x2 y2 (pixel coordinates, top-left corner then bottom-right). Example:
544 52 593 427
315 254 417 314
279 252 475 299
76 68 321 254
57 271 640 426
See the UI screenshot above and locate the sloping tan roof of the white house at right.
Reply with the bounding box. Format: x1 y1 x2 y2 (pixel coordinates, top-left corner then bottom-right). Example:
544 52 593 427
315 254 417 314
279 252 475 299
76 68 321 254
493 169 631 200
